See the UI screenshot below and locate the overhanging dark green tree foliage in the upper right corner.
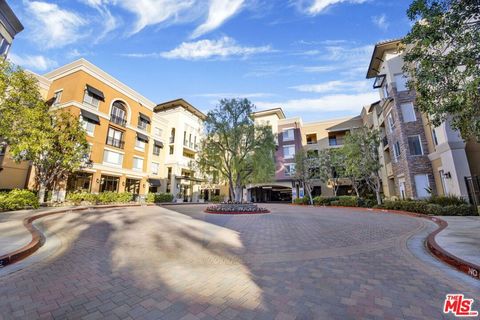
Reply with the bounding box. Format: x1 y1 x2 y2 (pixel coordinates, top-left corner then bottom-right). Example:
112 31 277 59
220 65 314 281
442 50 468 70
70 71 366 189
403 0 480 139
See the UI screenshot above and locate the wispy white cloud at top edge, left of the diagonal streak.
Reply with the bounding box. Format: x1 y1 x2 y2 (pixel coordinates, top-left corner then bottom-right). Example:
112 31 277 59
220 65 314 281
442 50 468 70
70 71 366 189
115 0 195 34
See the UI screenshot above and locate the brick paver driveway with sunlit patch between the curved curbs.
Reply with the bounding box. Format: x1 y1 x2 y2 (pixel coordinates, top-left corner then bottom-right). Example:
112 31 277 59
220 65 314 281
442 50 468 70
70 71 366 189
0 205 480 319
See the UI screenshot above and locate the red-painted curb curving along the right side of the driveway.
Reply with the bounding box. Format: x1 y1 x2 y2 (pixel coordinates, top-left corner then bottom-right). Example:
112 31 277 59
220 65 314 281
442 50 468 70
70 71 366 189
291 204 480 280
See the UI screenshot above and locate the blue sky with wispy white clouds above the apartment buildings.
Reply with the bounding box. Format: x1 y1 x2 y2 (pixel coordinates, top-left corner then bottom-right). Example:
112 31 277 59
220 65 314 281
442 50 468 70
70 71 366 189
8 0 410 121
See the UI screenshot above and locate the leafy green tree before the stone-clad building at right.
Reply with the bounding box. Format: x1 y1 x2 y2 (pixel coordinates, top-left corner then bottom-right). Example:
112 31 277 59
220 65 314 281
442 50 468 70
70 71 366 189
343 127 382 204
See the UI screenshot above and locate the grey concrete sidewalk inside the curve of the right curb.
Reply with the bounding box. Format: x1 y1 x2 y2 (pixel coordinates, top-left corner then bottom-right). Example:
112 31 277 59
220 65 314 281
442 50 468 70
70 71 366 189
435 216 480 265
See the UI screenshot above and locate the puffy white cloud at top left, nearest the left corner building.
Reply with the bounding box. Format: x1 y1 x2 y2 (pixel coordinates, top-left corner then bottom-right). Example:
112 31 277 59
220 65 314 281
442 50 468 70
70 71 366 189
26 1 87 49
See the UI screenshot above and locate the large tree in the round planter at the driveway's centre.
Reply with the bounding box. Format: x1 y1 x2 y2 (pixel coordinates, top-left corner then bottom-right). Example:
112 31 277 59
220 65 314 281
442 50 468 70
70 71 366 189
198 99 275 201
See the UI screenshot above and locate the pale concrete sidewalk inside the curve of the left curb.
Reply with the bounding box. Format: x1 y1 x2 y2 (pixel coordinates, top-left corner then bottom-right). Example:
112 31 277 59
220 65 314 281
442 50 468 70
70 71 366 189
0 206 78 256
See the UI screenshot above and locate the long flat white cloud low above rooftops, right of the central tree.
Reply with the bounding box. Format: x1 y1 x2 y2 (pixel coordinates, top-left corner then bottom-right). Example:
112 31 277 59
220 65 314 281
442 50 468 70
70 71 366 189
255 92 378 114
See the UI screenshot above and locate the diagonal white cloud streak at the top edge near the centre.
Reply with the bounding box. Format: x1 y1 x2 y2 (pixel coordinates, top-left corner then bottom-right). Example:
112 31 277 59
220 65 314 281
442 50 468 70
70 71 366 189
192 0 244 38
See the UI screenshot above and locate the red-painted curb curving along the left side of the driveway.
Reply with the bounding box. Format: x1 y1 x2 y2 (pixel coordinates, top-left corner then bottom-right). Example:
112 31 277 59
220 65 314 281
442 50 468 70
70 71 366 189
0 204 152 268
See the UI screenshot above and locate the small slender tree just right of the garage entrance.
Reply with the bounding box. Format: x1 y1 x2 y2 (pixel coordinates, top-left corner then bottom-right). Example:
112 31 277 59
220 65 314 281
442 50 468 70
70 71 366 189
294 150 320 205
